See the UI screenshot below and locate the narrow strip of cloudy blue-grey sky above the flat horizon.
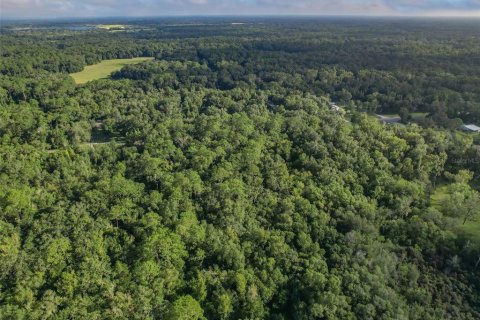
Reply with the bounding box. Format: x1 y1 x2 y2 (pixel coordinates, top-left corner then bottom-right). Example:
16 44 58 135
0 0 480 19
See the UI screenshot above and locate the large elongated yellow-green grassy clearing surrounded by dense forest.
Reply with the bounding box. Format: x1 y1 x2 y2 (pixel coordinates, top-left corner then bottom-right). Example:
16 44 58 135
70 57 153 84
